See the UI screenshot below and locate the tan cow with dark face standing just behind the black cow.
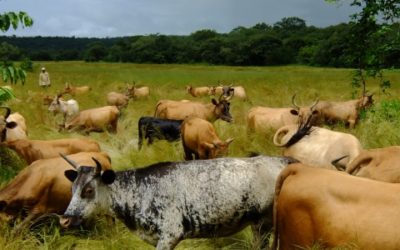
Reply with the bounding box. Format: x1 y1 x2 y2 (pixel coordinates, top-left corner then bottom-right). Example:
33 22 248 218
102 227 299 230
154 97 233 122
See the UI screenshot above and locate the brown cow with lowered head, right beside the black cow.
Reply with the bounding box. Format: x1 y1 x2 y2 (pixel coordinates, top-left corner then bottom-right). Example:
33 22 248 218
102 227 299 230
181 117 233 160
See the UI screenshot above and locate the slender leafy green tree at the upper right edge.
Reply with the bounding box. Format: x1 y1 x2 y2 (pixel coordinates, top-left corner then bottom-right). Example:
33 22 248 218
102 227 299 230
325 0 400 93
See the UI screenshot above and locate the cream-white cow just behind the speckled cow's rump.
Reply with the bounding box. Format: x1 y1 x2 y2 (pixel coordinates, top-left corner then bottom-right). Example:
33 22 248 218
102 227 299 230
274 119 362 169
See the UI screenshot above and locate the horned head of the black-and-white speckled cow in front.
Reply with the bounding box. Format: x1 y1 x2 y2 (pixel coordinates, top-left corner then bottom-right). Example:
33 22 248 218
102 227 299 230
60 155 115 228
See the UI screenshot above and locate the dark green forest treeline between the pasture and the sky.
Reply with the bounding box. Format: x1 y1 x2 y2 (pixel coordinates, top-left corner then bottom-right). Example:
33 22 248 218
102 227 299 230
0 17 400 67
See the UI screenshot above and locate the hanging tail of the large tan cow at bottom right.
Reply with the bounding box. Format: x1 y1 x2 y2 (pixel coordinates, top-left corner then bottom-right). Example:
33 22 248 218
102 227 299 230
270 165 297 250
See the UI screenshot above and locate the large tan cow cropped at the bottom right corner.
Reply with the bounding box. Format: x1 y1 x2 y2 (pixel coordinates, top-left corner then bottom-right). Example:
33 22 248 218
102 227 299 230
272 164 400 250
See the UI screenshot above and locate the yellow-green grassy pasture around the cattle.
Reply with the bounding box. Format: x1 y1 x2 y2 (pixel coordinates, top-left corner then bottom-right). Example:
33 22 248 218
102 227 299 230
0 62 400 249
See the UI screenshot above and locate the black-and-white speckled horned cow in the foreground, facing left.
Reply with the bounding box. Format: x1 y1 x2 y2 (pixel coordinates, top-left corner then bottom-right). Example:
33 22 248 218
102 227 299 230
60 156 291 249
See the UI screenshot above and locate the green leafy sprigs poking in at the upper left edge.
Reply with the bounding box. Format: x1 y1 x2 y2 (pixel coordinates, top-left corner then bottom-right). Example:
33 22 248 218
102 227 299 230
0 11 33 83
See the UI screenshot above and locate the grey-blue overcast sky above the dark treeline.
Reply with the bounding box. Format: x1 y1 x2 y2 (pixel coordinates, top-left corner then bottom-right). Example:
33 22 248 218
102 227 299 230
0 0 354 37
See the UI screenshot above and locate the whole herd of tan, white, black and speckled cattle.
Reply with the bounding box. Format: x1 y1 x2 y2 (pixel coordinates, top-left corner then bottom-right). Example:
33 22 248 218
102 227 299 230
0 81 400 249
